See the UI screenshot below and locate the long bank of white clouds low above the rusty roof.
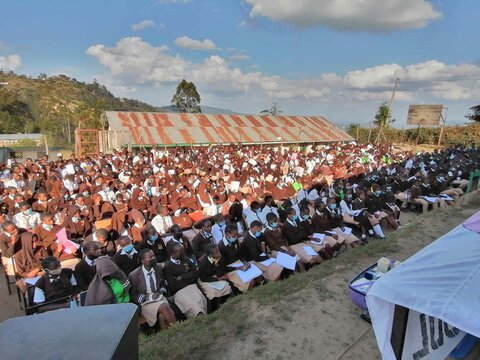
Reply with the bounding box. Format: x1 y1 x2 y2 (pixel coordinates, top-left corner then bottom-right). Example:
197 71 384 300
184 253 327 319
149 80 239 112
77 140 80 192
87 37 480 115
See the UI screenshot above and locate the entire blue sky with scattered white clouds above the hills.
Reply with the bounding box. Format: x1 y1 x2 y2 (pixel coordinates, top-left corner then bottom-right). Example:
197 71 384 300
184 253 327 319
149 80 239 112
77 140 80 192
0 0 480 126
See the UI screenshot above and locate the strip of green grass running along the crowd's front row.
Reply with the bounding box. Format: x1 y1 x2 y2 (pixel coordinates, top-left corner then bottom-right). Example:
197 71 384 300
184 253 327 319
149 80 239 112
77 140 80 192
140 192 479 360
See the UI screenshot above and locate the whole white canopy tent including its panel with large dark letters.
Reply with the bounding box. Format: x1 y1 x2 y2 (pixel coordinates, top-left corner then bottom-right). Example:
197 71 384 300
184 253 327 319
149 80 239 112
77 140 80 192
366 212 480 360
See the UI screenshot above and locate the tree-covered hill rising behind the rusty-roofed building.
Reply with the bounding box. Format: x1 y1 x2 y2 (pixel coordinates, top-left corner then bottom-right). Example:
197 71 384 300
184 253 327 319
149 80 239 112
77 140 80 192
0 70 238 146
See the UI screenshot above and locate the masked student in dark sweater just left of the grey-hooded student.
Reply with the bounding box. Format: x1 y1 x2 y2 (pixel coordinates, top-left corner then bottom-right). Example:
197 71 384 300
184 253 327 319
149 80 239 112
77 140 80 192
33 256 77 312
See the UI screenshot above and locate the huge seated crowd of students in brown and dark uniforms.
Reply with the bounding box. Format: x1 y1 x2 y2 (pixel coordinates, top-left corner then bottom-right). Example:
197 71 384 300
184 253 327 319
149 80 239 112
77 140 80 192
0 143 480 328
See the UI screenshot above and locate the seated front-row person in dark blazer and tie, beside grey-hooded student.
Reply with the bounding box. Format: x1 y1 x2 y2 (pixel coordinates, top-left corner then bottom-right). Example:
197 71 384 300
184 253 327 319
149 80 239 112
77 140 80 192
128 249 176 329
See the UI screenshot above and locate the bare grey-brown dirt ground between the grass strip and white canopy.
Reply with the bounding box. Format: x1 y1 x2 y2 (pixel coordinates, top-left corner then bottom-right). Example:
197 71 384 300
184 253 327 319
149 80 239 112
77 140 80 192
212 193 480 360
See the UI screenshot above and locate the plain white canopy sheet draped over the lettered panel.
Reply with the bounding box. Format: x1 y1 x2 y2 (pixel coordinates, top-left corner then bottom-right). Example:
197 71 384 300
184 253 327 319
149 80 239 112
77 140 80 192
366 212 480 359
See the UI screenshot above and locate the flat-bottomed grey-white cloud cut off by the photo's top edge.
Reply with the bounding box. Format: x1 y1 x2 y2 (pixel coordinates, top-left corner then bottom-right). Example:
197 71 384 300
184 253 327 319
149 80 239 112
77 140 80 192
245 0 441 32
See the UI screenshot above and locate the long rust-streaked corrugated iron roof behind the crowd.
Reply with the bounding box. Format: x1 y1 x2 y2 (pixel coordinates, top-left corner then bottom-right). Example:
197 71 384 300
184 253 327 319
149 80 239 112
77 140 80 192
106 111 353 145
